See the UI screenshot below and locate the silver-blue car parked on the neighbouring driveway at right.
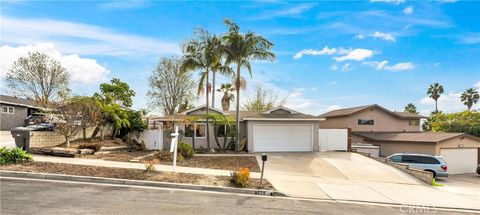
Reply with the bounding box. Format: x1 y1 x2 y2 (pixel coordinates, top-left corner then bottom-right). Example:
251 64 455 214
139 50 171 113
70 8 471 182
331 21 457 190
387 153 448 178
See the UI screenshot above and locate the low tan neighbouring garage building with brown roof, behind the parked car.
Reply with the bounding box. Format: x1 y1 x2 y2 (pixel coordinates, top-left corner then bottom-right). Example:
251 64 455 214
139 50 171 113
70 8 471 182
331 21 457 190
352 132 480 174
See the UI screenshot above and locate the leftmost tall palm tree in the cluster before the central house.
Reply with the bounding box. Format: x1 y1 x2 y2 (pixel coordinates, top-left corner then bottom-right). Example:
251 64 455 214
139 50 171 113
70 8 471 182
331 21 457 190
182 29 223 151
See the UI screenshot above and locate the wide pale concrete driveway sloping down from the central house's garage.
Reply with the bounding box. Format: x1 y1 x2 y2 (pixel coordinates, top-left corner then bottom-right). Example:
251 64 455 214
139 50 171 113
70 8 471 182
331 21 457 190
257 152 480 209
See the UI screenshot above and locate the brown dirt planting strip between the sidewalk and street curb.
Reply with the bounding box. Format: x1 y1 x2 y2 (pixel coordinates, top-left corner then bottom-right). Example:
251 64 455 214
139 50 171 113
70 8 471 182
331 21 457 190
0 162 274 190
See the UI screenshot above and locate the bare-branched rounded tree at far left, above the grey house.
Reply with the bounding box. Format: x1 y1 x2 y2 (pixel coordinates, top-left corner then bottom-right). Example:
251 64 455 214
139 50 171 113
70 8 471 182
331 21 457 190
5 52 70 106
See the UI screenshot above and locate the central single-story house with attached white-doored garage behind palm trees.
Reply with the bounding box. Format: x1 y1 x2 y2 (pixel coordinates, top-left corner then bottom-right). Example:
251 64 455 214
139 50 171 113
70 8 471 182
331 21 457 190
155 106 322 152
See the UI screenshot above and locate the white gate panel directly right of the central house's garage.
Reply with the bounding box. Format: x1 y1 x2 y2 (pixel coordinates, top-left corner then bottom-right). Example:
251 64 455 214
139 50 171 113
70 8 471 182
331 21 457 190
318 128 348 151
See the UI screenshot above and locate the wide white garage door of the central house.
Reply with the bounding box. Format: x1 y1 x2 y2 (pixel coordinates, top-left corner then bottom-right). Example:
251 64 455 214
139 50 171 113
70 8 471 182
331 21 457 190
253 124 313 152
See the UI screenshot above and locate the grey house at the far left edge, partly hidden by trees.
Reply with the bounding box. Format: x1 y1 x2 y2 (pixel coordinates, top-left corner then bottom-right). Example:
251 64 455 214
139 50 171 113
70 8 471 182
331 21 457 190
0 95 42 131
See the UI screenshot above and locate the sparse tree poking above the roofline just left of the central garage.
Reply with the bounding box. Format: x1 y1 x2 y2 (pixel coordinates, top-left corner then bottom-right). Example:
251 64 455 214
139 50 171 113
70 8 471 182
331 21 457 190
243 85 286 111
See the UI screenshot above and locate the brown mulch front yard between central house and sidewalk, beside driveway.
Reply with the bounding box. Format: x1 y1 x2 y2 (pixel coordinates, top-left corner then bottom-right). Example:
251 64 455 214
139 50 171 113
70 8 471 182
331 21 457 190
147 156 260 172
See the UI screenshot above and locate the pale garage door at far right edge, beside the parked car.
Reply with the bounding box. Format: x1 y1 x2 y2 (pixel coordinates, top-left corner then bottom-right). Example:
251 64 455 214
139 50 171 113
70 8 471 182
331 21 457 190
440 148 478 174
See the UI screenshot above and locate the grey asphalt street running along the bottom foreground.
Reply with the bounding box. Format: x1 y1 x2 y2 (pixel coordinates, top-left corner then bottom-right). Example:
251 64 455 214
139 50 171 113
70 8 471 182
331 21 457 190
0 178 474 215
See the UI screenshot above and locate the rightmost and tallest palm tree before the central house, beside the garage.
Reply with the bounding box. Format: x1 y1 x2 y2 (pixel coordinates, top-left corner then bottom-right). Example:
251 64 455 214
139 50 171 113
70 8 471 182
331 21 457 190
222 19 275 150
